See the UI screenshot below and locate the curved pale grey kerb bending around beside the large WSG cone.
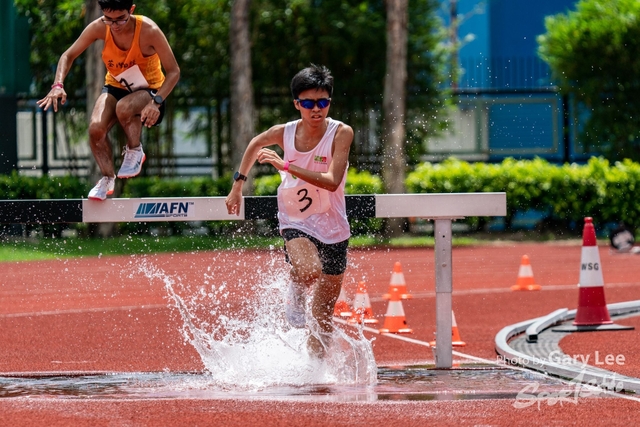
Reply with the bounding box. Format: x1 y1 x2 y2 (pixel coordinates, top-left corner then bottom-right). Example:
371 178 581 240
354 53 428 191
495 300 640 394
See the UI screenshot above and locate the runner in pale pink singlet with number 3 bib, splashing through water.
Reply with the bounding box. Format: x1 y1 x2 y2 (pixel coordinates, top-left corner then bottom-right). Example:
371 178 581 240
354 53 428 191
226 65 353 357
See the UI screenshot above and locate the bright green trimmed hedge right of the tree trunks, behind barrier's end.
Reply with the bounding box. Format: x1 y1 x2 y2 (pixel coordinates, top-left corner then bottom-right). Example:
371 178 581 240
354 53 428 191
406 157 640 228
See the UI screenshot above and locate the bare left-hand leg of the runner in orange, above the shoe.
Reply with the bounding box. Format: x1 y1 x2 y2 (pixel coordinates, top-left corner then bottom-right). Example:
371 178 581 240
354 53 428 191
89 93 117 177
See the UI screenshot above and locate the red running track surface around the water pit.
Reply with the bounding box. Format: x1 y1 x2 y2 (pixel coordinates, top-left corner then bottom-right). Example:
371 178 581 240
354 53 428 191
0 243 640 426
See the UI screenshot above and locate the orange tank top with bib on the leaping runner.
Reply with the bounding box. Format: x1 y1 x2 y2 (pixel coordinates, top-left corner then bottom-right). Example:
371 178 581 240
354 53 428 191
102 15 164 92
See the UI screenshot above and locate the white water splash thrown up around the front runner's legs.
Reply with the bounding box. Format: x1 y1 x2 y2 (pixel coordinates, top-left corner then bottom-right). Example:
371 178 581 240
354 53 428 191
138 257 377 390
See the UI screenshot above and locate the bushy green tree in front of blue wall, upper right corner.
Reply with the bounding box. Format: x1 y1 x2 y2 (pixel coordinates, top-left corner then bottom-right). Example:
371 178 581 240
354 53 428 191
538 0 640 160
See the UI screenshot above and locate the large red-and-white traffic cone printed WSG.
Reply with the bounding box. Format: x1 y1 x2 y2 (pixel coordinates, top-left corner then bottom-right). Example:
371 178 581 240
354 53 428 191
553 218 633 332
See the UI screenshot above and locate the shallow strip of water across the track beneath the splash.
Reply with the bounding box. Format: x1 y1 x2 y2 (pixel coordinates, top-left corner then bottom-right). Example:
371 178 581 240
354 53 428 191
0 364 574 402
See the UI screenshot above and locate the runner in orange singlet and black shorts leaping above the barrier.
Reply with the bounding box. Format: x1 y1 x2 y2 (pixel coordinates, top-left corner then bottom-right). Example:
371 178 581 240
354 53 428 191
38 0 180 200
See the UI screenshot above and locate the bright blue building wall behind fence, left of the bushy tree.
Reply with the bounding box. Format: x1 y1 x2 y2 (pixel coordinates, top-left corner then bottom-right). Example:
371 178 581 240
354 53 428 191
442 0 587 162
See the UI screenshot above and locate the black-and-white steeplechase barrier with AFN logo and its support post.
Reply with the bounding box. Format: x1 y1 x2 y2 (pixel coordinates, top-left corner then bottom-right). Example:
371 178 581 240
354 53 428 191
0 193 507 369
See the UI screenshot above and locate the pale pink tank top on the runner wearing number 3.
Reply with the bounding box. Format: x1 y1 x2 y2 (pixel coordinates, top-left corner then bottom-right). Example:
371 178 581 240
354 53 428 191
278 118 351 244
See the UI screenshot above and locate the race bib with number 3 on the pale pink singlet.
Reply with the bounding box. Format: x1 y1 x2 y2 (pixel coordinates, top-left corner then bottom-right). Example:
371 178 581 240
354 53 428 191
280 184 331 221
